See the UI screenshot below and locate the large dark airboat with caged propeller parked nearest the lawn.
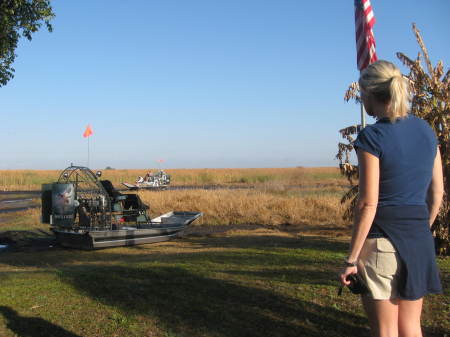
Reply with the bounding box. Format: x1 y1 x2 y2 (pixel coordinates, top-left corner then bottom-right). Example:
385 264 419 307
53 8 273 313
41 165 202 249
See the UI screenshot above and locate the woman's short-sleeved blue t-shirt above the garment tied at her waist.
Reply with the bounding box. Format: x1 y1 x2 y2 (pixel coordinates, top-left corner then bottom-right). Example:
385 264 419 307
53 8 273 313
353 115 437 207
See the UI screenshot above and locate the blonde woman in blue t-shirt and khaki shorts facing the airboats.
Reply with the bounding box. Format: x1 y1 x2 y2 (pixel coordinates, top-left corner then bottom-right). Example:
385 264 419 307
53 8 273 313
340 61 444 337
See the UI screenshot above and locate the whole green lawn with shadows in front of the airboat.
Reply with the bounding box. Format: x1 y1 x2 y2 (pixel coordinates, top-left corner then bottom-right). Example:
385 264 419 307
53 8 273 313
0 222 450 337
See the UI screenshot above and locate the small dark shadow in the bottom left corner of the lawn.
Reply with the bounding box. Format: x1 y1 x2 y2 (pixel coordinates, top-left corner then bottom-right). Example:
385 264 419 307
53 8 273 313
0 306 80 337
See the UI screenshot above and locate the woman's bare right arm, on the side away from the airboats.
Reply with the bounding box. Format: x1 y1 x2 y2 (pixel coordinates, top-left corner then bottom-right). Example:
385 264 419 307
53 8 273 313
427 147 444 227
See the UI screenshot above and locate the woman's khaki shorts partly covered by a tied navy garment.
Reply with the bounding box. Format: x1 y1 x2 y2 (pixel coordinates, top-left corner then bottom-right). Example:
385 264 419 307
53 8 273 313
358 238 401 300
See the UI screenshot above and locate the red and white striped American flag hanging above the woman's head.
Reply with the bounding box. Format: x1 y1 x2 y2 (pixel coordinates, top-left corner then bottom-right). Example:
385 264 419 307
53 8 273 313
355 0 378 71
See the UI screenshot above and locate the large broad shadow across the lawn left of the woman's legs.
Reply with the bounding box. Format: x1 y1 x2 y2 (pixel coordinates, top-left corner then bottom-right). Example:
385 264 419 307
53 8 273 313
60 265 368 337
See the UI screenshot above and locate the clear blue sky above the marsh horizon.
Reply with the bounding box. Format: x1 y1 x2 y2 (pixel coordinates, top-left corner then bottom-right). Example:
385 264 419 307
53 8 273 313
0 0 450 169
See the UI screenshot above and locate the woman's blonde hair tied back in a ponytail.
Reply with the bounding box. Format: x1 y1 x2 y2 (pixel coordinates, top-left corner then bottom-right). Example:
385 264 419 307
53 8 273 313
359 60 409 123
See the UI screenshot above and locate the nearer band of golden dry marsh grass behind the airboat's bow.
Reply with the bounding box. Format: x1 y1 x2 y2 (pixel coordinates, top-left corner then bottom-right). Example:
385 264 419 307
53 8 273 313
140 189 345 226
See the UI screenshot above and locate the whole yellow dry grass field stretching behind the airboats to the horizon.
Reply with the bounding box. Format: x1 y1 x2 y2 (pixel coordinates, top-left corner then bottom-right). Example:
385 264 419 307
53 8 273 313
0 167 347 228
